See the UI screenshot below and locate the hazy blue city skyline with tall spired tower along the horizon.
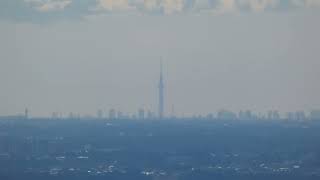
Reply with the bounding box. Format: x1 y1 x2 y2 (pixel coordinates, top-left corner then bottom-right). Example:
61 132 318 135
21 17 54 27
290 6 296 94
0 56 320 119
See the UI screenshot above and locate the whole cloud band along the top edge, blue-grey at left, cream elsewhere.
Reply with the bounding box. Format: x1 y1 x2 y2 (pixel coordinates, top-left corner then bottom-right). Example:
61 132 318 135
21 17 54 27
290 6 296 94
0 0 320 22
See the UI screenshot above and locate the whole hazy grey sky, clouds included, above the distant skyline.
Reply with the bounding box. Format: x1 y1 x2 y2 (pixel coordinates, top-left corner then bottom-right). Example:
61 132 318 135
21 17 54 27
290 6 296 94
0 0 320 116
